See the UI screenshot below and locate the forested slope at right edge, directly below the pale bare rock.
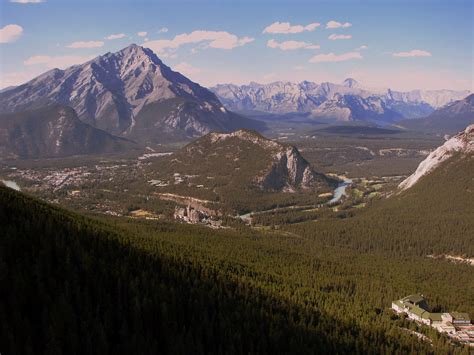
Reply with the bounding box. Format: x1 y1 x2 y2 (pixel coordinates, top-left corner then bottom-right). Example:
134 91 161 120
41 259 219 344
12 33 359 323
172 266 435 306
285 154 474 258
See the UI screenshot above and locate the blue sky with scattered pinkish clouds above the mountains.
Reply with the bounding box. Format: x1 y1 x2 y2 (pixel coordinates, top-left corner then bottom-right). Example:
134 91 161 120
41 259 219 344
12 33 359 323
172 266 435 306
0 0 474 90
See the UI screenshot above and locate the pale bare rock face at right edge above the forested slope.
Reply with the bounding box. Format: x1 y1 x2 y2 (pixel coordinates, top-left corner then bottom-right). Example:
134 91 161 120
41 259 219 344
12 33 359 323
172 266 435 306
399 124 474 190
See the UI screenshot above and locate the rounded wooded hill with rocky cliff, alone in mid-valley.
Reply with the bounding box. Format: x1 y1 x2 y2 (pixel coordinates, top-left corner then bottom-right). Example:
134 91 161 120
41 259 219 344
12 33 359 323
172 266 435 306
145 130 336 214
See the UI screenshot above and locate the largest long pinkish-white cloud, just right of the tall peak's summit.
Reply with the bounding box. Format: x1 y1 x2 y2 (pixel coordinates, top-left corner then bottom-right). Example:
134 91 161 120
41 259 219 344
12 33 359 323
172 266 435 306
143 30 254 57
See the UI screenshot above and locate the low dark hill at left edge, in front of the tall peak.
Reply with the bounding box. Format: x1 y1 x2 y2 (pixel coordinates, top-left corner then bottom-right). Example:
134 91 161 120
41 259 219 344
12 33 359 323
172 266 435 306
0 105 134 159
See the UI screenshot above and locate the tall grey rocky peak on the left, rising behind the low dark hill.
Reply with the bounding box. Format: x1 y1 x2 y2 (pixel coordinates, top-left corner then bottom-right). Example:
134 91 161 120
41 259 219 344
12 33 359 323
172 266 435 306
0 45 263 143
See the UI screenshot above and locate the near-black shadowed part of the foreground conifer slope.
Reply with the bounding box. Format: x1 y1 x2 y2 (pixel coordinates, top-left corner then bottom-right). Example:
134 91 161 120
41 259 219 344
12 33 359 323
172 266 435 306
0 186 348 355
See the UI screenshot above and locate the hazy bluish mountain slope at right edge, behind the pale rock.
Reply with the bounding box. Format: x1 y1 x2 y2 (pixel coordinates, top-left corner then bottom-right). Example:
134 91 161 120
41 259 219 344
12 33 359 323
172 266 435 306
400 94 474 134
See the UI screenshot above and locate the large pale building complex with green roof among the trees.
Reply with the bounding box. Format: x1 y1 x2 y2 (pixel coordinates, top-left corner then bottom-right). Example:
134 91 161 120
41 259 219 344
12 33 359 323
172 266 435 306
392 294 474 347
